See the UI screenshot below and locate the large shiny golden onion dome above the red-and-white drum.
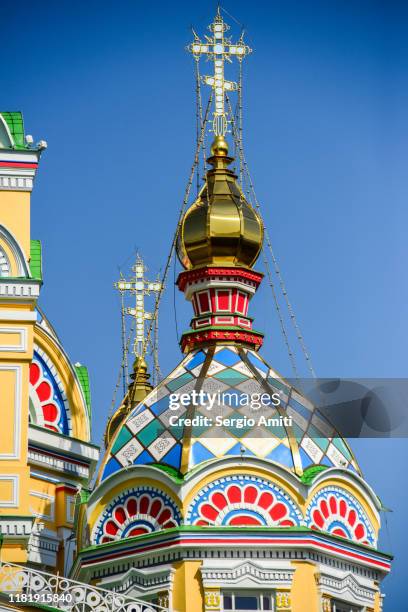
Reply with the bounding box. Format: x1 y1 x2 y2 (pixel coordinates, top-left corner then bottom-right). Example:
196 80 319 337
177 136 263 269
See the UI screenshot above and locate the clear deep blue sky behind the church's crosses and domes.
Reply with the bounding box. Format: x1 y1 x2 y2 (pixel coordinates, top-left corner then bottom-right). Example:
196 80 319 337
0 0 408 612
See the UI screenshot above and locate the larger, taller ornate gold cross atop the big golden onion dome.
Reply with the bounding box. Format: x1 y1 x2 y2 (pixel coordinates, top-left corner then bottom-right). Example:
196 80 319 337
187 7 252 136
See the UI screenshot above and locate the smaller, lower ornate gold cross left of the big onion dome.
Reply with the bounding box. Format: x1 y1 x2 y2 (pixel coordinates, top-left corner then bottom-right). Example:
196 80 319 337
114 255 162 356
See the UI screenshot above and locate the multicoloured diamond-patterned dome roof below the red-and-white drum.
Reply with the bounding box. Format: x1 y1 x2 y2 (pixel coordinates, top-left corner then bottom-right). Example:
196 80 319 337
101 345 359 480
